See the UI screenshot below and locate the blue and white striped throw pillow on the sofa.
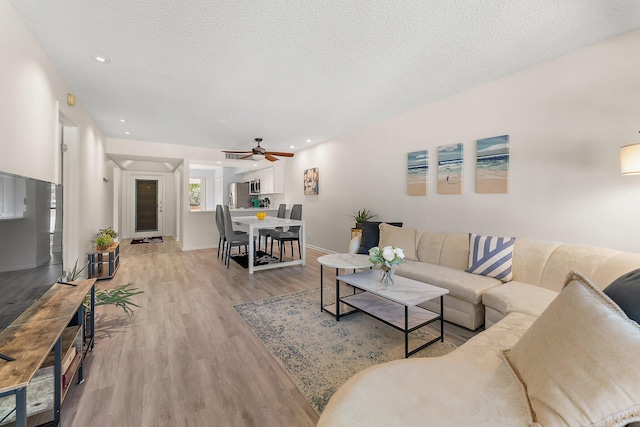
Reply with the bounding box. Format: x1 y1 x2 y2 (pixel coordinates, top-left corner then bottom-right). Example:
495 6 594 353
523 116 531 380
465 234 516 282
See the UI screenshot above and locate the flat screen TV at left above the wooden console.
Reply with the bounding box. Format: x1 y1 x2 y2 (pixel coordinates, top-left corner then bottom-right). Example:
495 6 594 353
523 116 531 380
0 172 63 330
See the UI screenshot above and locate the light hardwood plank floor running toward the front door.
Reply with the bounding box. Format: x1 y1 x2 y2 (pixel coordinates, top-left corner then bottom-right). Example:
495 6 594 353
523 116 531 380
62 238 473 427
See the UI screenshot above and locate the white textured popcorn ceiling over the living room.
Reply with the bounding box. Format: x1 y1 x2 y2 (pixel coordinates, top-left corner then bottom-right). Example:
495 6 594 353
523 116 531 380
11 0 640 150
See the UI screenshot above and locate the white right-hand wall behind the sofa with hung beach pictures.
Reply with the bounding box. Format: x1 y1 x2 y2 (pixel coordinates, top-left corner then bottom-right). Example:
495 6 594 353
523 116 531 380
287 31 640 252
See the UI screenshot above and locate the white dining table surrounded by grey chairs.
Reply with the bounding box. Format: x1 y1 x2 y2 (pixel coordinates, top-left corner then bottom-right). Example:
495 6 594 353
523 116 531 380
231 216 306 274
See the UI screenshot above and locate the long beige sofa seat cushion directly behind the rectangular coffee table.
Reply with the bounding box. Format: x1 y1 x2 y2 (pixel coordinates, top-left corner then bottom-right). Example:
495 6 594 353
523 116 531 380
396 261 502 304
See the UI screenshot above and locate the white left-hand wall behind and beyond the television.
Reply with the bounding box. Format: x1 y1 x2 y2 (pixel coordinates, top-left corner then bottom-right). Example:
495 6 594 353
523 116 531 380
0 0 112 268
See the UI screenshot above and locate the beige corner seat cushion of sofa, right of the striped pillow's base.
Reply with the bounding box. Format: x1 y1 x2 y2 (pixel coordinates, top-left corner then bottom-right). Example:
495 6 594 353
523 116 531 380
482 280 558 317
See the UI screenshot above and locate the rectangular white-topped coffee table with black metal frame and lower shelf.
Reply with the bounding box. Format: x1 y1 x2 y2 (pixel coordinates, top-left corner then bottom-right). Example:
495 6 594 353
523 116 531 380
335 270 449 358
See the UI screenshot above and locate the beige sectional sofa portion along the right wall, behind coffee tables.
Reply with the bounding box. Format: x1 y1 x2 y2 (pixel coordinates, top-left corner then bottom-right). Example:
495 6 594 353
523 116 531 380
349 224 640 330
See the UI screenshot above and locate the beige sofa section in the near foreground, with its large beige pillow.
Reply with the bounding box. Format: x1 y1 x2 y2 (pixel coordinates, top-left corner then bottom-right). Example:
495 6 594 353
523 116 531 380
318 272 640 427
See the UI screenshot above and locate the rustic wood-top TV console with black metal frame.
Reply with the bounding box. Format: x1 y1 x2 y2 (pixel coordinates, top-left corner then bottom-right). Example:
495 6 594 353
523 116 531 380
0 279 96 427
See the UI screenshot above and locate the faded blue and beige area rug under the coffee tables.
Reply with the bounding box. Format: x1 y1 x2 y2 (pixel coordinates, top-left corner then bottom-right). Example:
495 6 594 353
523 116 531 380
234 289 456 414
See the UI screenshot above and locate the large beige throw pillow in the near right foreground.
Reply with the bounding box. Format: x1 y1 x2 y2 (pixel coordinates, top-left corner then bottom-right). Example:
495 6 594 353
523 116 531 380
503 271 640 426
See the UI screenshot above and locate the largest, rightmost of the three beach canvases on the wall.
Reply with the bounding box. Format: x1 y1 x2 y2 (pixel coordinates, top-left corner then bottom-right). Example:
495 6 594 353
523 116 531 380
476 135 509 194
